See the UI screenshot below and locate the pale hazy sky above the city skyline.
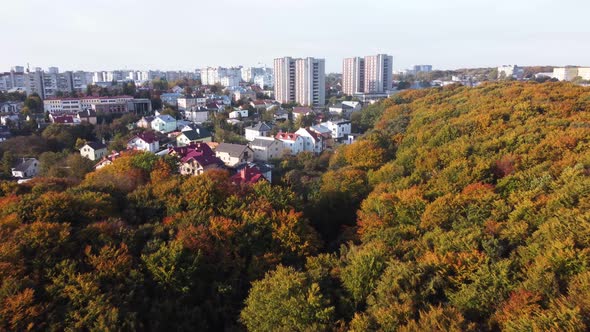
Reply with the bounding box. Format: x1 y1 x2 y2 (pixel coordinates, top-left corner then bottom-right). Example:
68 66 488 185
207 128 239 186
0 0 590 72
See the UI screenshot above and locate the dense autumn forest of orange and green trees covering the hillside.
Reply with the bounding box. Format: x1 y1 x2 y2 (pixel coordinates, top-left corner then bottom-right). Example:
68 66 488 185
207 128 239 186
0 82 590 331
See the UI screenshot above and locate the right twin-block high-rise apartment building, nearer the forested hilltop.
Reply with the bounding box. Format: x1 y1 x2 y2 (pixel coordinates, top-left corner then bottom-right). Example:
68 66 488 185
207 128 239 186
342 54 393 95
